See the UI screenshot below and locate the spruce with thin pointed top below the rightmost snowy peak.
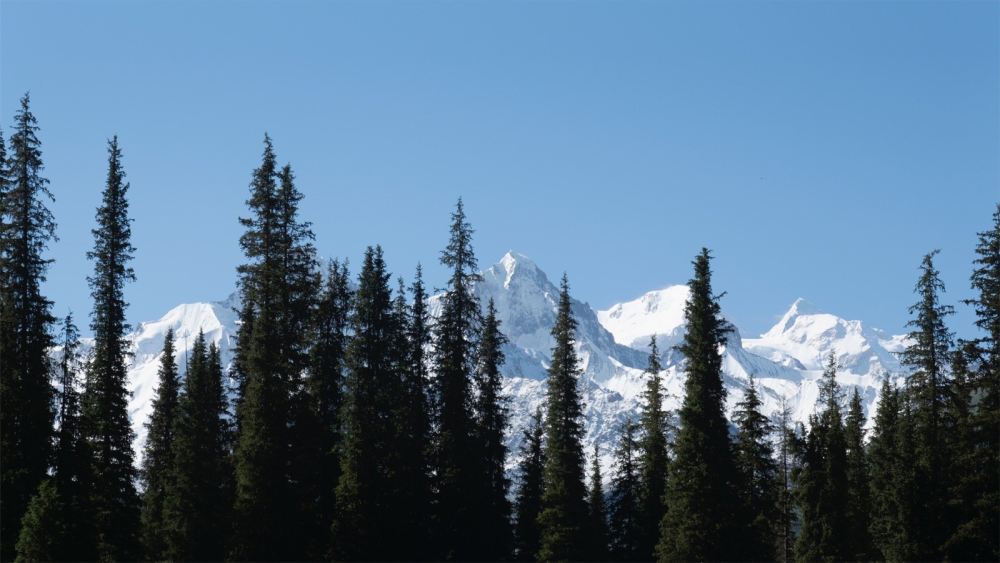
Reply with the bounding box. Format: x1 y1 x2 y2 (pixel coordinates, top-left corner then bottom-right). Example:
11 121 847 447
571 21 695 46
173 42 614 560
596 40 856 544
795 352 848 561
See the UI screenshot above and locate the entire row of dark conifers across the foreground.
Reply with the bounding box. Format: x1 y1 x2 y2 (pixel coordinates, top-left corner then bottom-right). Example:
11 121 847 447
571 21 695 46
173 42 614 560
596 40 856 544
0 94 1000 561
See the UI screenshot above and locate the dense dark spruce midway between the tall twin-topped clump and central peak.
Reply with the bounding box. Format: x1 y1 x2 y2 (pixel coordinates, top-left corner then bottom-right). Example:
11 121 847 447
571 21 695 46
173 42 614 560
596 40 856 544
334 247 405 561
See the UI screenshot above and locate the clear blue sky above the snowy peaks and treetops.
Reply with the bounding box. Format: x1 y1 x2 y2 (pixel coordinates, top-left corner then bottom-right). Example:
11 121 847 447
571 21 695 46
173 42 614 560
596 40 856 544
0 0 1000 336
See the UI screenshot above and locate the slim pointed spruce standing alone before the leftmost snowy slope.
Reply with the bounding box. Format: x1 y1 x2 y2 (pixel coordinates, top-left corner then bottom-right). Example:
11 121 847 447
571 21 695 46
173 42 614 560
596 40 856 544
140 328 180 561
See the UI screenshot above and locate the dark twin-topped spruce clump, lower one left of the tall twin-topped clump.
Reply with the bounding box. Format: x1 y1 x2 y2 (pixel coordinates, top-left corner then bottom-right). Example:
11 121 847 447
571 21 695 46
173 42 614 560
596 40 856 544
163 332 230 561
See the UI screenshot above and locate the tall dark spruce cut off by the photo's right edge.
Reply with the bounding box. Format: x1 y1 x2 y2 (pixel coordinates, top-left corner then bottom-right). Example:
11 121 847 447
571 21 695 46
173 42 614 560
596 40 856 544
946 204 1000 561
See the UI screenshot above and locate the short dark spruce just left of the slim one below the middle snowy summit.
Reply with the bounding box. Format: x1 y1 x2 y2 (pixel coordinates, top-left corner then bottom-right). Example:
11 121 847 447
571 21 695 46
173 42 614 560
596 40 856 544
609 418 645 561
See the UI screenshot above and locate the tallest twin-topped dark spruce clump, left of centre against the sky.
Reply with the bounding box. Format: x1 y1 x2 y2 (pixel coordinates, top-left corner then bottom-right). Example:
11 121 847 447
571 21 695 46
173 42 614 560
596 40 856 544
230 135 319 560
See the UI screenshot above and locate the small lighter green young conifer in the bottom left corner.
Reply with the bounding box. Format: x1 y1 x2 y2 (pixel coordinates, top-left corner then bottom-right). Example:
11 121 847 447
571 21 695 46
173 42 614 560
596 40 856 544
16 479 67 562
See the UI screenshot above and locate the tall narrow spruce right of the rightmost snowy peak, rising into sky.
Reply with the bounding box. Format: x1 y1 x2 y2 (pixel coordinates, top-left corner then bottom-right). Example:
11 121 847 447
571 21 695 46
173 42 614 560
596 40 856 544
902 250 954 560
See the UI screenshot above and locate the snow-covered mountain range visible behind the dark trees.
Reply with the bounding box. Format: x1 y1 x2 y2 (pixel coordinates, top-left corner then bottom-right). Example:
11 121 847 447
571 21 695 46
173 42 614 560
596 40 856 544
83 252 904 474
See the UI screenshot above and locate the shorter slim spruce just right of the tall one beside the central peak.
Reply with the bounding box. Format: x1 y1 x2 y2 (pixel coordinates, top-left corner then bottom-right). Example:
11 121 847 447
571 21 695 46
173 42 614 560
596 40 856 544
473 299 512 561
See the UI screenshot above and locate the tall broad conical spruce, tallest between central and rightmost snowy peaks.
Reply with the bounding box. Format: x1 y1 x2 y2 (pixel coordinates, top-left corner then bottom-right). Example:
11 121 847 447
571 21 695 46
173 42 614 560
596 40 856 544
657 248 742 561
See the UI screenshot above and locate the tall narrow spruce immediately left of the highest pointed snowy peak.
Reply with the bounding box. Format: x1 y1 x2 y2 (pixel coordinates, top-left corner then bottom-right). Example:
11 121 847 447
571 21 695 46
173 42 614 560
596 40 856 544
433 198 484 560
